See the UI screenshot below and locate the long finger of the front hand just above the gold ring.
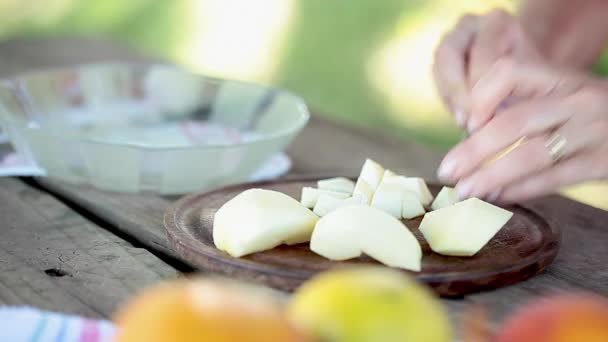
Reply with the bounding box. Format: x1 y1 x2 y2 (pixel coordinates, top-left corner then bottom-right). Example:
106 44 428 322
438 100 574 183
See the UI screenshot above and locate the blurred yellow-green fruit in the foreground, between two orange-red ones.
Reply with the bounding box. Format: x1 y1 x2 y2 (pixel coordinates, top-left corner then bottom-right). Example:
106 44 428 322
288 267 451 342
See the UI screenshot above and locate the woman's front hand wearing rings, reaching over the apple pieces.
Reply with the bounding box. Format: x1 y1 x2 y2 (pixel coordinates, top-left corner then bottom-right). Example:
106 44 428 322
439 59 608 202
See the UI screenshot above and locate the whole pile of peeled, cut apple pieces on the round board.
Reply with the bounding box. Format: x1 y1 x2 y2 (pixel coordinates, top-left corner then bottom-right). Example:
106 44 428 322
213 159 513 271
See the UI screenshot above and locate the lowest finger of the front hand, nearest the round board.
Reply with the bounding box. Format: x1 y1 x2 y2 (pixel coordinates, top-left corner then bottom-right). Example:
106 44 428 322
497 149 608 203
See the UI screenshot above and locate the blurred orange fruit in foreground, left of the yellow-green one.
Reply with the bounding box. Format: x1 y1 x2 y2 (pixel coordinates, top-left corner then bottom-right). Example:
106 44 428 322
115 279 305 342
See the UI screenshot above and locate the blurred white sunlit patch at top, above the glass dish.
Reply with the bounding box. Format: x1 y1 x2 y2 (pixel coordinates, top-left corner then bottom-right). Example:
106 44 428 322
177 0 294 82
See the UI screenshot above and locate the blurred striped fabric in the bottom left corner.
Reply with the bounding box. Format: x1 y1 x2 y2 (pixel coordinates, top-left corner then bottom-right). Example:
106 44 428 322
0 306 114 342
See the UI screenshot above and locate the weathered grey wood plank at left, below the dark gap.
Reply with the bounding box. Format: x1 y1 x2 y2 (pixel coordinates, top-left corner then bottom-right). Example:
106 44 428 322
0 178 177 317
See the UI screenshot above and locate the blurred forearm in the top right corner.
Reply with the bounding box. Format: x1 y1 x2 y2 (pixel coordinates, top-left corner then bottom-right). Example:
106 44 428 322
519 0 608 68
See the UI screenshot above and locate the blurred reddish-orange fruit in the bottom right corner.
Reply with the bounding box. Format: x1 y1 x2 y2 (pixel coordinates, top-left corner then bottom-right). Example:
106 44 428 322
495 293 608 342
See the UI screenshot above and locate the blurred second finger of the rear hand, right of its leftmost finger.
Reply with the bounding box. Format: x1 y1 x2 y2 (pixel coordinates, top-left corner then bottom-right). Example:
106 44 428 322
468 10 517 86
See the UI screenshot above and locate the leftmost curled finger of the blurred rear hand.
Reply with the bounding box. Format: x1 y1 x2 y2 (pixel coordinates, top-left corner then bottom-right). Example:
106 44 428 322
433 15 478 126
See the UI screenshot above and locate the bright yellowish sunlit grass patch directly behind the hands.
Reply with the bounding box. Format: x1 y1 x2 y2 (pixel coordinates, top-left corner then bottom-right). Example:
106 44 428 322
368 0 512 131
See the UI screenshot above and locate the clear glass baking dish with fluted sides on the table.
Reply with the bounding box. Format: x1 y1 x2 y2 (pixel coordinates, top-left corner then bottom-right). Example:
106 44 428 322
0 63 309 194
